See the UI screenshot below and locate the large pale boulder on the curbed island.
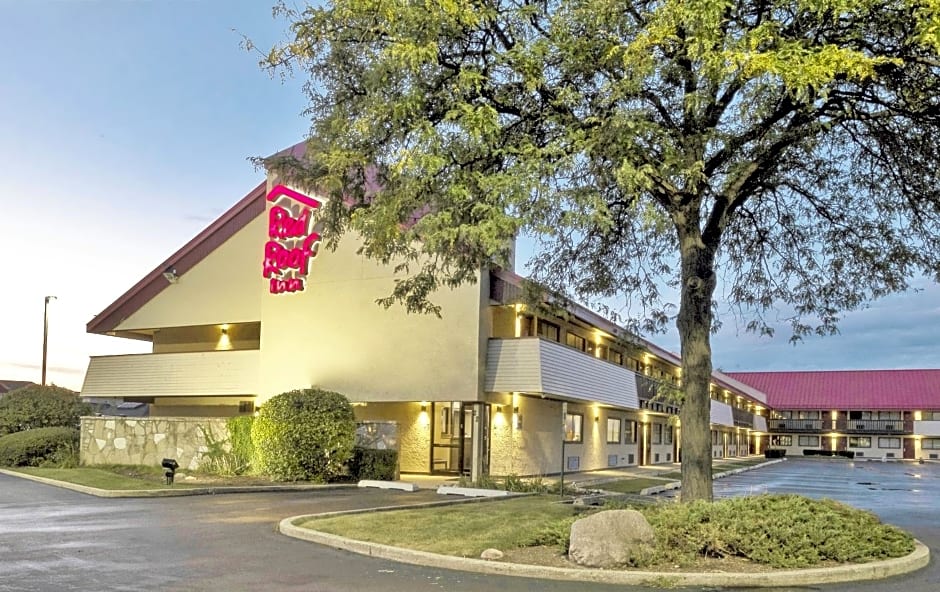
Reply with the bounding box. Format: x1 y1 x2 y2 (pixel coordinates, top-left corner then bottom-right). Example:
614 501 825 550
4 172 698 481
568 510 654 568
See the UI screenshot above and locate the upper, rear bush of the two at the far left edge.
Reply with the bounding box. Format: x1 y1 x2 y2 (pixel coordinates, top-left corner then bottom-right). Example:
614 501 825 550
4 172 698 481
0 385 92 435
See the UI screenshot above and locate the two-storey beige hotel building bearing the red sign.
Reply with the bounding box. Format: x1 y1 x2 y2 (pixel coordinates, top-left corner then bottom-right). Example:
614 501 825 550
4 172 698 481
82 160 768 478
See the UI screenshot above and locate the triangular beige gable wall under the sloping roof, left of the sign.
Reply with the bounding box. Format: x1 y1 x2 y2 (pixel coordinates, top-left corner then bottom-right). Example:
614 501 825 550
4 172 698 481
117 216 267 331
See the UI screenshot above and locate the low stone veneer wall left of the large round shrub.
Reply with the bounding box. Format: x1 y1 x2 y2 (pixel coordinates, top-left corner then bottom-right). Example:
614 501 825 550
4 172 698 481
81 417 228 470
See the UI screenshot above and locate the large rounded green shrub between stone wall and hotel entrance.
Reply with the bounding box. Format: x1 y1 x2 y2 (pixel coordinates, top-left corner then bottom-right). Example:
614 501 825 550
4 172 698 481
251 389 356 481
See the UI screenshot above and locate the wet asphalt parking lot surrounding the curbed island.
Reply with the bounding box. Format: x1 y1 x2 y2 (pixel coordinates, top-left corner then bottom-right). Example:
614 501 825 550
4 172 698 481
0 459 940 592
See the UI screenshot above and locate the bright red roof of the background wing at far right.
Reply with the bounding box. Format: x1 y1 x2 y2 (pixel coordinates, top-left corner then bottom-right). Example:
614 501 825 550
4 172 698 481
728 370 940 411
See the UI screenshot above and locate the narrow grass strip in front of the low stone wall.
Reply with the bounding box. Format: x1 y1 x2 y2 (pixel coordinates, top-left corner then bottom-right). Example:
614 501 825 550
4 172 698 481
8 465 280 490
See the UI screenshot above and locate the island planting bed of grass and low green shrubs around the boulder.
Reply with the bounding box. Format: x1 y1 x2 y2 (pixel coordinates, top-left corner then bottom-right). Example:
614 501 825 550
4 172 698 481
297 495 914 572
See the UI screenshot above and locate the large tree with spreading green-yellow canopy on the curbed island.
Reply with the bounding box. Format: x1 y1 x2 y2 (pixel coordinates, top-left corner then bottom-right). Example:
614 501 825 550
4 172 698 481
262 0 940 500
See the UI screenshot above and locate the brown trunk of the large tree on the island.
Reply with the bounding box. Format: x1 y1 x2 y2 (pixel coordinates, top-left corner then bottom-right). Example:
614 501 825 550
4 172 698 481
676 234 716 502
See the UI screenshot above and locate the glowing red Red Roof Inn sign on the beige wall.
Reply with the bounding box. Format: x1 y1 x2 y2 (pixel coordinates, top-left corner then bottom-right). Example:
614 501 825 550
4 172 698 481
264 185 322 294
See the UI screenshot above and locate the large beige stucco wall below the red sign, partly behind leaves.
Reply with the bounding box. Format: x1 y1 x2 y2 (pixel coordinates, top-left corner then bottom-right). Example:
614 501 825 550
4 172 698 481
257 219 485 408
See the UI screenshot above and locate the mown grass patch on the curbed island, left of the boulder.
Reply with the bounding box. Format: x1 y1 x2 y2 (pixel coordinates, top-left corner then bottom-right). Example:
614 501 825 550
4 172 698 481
298 496 574 557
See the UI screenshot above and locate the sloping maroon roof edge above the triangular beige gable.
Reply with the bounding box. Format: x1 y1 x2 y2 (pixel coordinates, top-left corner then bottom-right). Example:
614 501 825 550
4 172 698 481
86 181 267 333
